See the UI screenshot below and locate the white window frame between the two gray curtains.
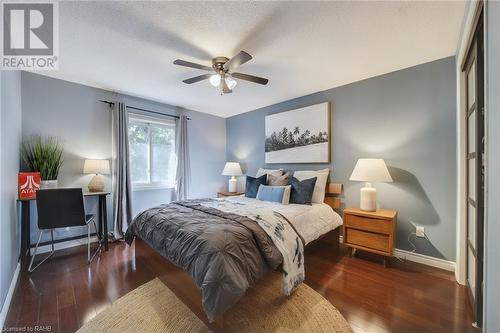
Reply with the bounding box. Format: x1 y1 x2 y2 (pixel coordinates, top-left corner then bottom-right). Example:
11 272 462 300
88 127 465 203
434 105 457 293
127 112 177 191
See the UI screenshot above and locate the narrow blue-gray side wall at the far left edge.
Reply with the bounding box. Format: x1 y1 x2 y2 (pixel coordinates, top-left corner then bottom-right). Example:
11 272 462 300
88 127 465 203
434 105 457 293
0 71 21 309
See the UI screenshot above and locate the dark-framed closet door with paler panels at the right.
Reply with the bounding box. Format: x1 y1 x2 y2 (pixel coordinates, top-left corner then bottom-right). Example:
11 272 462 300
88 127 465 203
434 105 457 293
463 8 484 327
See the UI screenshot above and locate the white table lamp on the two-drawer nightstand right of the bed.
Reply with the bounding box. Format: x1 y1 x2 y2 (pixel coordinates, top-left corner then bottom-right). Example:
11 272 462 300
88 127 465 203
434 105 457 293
349 158 392 212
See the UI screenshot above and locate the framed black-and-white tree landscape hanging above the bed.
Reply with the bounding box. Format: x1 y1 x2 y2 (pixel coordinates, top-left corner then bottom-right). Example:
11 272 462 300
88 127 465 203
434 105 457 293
265 102 331 163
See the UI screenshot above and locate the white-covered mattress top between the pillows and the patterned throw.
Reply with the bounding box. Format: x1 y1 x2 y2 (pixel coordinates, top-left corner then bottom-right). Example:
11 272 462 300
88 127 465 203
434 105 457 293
221 196 343 245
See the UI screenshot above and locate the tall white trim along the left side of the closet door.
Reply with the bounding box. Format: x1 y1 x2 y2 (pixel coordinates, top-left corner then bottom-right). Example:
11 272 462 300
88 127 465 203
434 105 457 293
455 0 479 285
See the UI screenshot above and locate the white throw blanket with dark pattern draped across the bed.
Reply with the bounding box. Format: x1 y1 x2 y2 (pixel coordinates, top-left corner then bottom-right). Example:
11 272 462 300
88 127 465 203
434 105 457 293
202 199 305 296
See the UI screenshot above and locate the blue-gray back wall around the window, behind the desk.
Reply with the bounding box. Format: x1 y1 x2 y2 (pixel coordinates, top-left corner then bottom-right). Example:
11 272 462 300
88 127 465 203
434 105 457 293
21 72 226 242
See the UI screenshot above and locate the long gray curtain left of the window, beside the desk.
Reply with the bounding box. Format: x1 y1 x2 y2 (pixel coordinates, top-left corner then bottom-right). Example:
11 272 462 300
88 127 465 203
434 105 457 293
112 102 132 239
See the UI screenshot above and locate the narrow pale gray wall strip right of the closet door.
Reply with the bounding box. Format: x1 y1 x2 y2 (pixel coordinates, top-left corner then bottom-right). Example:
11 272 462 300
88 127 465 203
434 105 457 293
484 1 500 332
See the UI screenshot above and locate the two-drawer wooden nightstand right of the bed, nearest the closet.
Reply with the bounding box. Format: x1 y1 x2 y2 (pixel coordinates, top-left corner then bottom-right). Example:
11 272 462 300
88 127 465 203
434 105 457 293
343 207 398 266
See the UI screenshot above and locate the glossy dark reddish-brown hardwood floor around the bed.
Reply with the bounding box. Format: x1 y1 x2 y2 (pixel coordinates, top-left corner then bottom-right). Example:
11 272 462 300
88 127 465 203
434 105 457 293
5 241 477 333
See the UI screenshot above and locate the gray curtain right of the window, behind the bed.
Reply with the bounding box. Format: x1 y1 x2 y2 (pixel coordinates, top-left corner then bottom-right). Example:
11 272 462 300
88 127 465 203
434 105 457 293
175 116 191 200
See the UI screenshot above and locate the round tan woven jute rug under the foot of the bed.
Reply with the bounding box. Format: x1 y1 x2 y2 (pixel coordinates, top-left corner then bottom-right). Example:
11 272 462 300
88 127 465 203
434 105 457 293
78 275 352 333
